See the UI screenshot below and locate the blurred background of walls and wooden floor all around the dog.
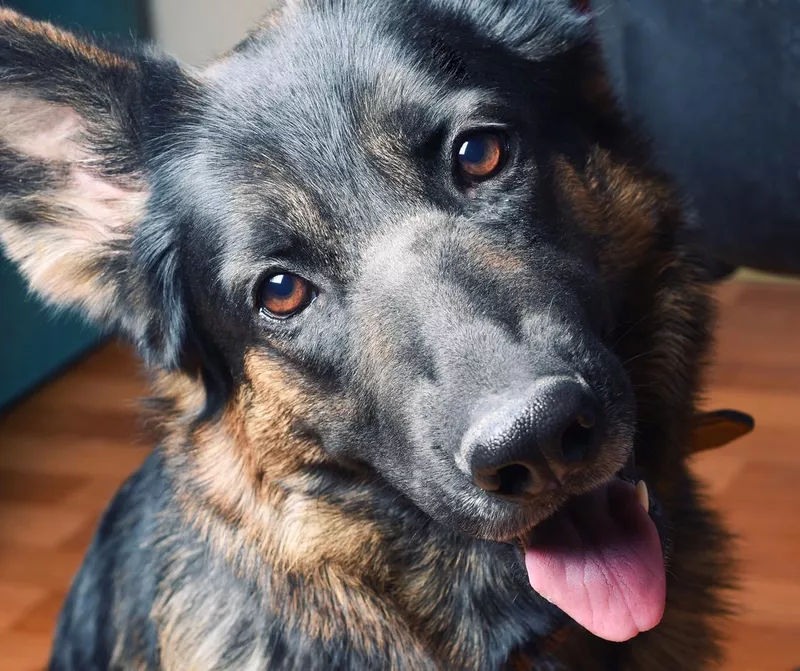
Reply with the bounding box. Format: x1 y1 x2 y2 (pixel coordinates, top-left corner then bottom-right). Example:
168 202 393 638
0 0 800 671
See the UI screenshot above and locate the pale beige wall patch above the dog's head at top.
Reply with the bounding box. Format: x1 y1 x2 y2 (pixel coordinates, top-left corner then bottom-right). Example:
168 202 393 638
150 0 277 65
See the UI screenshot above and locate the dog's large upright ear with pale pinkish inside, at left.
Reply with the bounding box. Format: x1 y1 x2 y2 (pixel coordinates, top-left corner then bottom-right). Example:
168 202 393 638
0 9 198 366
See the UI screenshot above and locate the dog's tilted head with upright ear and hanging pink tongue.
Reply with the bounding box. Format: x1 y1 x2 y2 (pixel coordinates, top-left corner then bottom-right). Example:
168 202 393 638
0 0 708 639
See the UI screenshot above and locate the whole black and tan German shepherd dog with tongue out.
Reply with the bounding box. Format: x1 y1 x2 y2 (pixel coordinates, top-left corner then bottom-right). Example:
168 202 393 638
0 0 730 671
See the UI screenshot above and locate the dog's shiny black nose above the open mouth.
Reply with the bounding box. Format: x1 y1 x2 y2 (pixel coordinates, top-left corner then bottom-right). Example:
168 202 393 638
462 377 603 499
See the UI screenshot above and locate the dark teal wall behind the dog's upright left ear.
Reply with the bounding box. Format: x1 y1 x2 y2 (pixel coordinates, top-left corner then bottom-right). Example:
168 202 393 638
0 0 146 411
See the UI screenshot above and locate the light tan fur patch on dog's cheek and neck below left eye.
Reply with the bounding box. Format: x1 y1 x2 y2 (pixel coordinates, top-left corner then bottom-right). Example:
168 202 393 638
162 354 388 573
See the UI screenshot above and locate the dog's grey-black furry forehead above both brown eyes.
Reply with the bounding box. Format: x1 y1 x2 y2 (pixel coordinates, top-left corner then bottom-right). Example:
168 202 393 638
177 0 588 294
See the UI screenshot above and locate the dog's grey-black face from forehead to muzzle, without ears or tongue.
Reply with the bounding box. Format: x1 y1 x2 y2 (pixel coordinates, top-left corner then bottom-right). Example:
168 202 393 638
188 3 634 539
